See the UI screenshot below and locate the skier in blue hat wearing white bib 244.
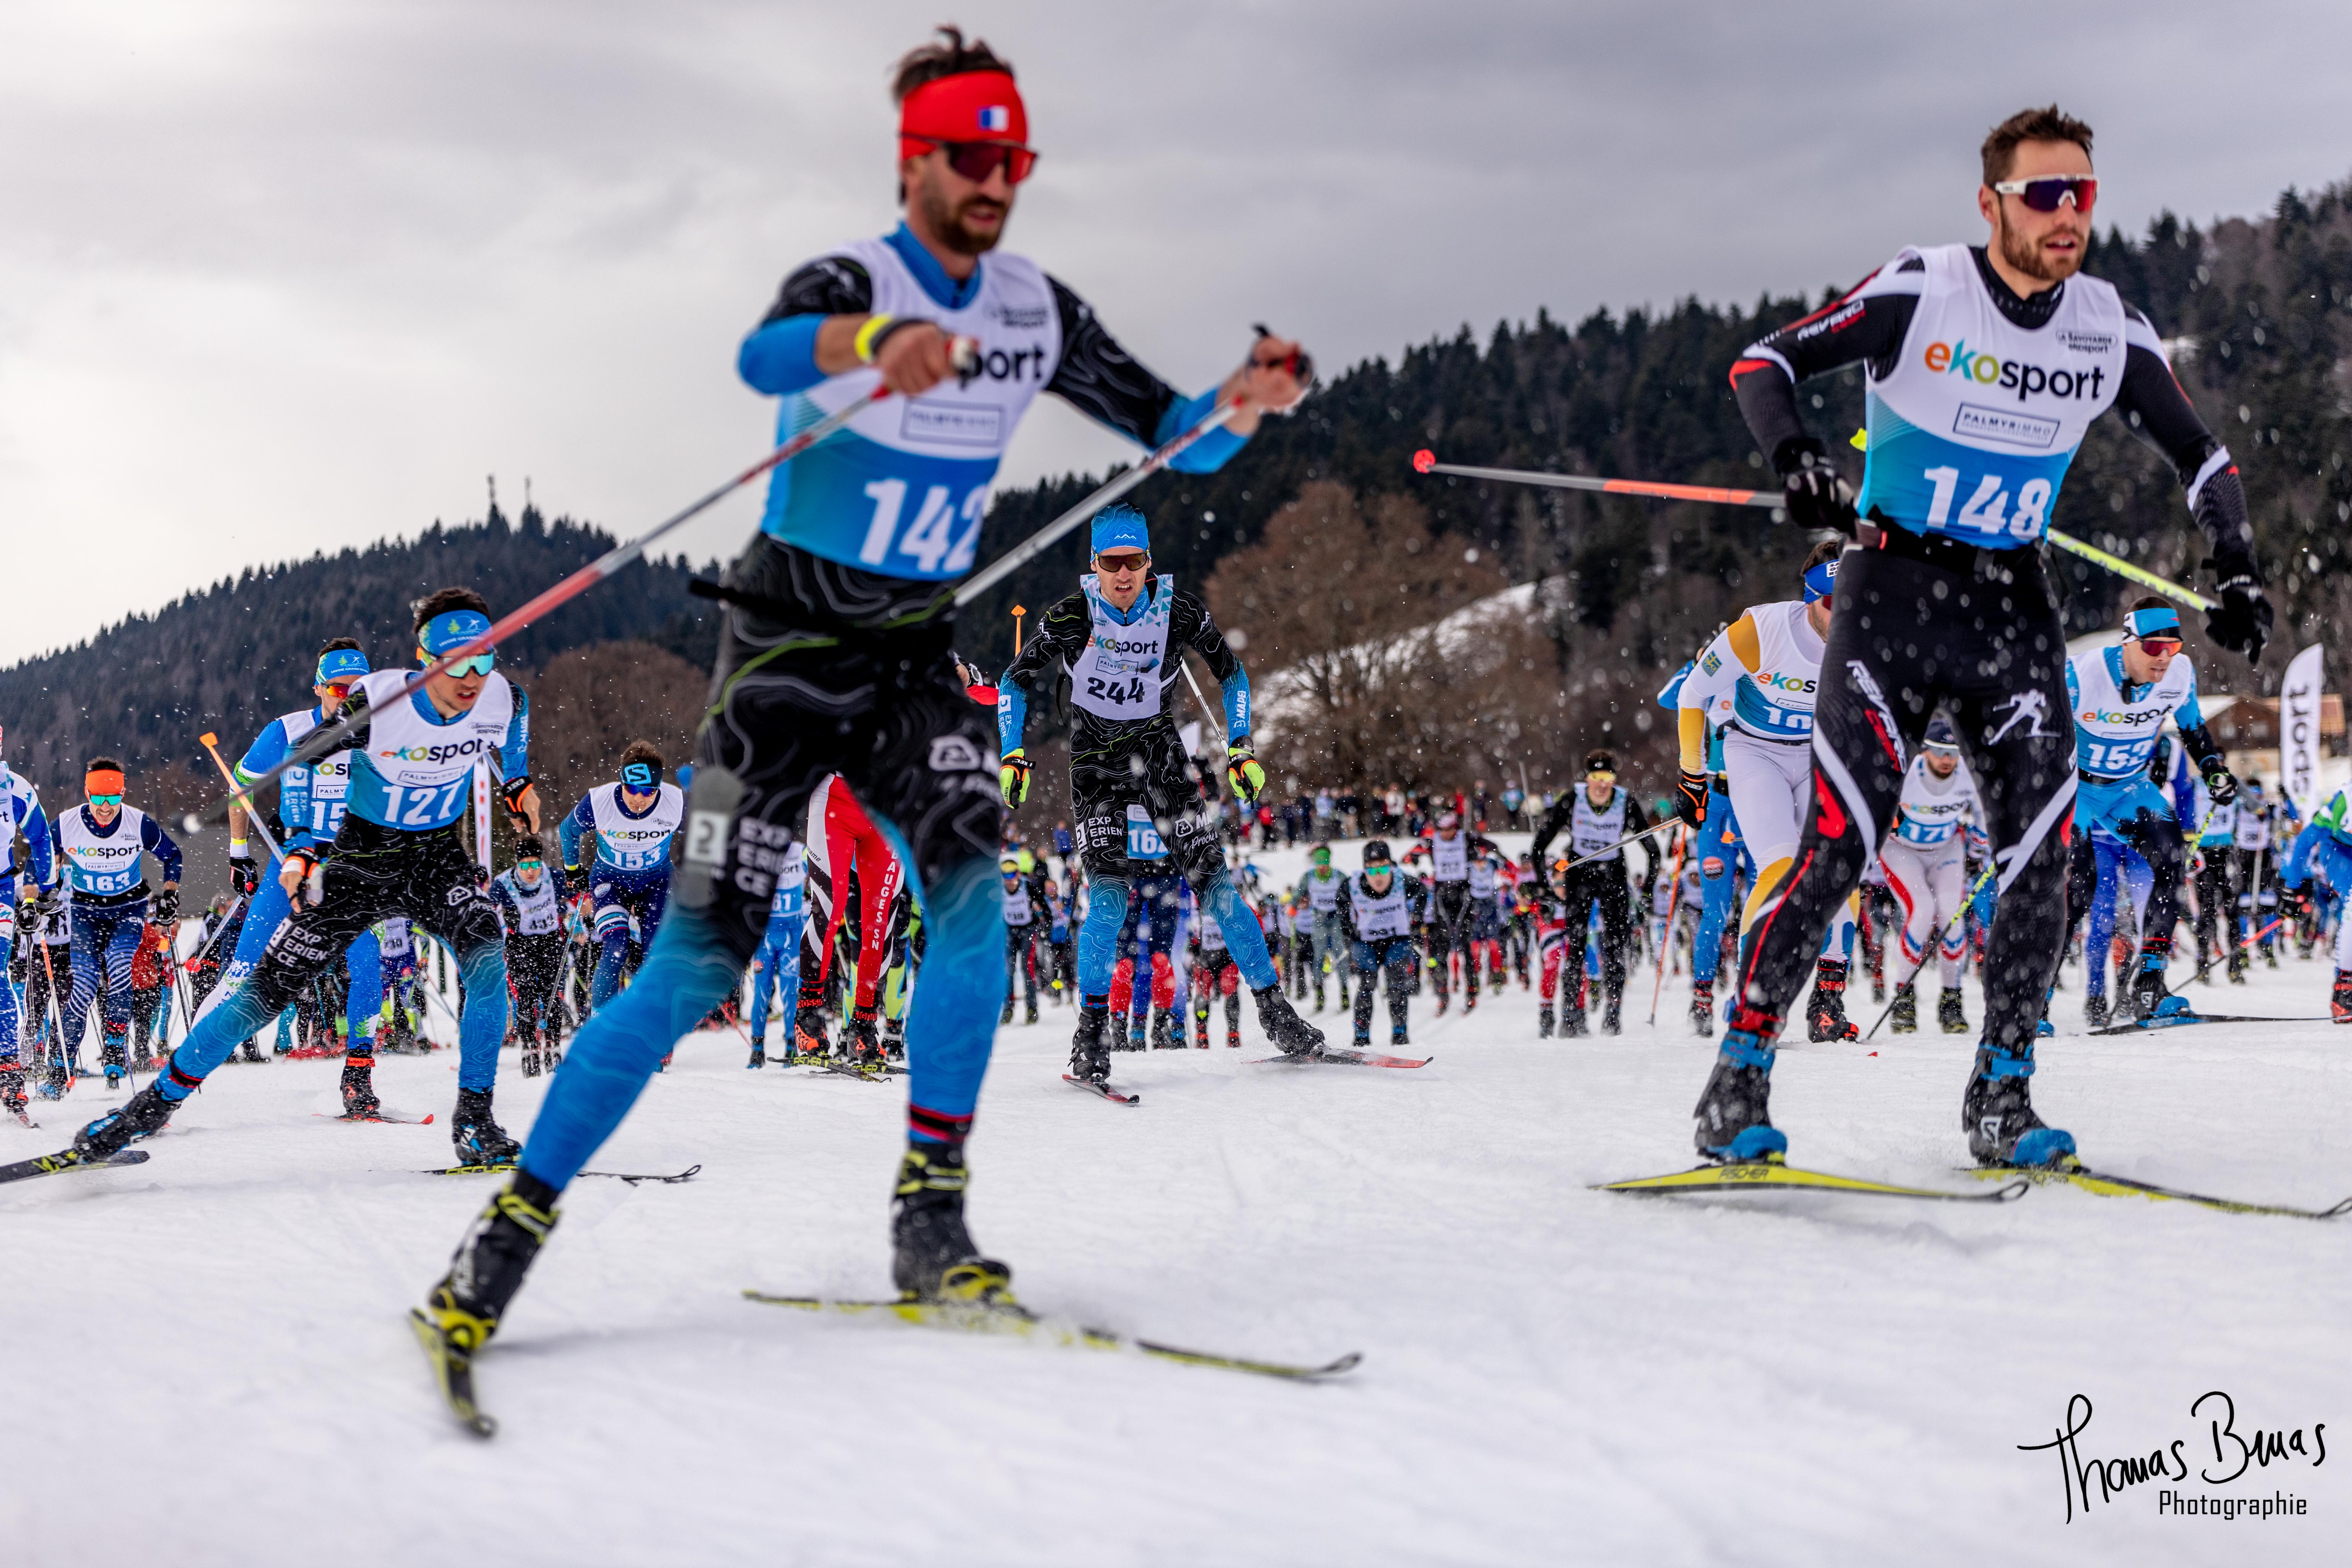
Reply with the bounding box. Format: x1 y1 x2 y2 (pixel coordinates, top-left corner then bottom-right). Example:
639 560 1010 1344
997 505 1322 1081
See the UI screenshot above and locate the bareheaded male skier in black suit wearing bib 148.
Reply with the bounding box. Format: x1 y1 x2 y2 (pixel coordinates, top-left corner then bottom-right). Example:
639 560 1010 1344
1694 106 2272 1166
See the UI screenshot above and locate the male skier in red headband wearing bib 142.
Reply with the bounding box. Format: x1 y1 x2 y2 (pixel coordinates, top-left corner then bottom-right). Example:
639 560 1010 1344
412 28 1303 1382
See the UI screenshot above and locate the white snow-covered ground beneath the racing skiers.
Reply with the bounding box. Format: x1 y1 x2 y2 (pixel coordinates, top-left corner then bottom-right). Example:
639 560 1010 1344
0 846 2352 1568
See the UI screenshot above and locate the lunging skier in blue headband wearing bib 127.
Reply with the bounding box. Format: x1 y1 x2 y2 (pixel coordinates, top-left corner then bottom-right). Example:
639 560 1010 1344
73 588 539 1164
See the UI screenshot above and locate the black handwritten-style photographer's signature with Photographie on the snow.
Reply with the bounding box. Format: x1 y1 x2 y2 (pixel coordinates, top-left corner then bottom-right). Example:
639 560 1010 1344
2018 1389 2329 1523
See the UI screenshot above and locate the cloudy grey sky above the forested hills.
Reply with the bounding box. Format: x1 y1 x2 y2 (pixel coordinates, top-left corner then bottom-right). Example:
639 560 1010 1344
0 0 2352 663
